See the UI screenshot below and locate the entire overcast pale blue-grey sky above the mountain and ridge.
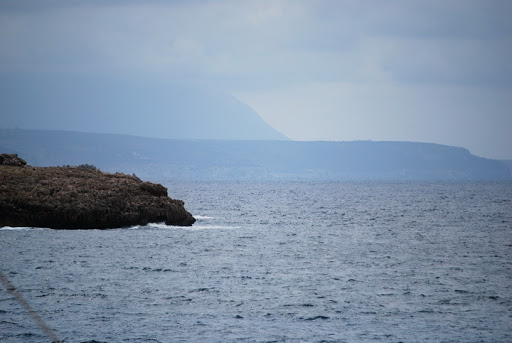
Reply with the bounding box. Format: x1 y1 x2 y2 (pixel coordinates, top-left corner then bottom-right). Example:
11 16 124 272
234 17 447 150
0 0 512 159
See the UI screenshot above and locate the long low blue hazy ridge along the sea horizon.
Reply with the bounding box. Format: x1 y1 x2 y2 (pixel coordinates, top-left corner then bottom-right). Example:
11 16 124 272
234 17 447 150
0 130 511 180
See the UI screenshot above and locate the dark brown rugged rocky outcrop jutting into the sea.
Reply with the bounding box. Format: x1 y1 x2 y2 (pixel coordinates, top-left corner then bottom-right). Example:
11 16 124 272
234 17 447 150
0 154 195 229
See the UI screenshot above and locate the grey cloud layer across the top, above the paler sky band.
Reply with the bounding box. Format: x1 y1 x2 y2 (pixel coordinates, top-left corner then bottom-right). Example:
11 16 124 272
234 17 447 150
0 1 512 87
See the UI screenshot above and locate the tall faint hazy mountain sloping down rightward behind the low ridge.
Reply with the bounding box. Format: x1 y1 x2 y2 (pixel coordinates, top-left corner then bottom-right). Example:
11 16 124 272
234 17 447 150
0 73 287 140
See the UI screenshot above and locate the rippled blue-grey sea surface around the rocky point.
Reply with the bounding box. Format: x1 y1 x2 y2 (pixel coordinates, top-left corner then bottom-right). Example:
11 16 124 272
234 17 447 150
0 182 512 342
